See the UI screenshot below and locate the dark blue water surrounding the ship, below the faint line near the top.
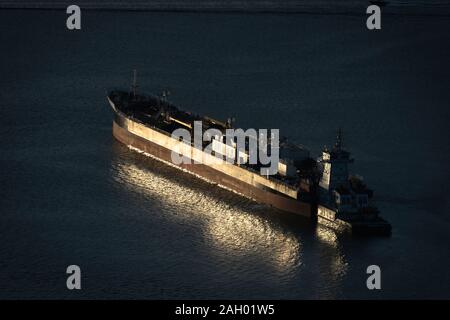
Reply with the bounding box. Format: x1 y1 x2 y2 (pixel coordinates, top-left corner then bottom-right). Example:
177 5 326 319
0 10 450 299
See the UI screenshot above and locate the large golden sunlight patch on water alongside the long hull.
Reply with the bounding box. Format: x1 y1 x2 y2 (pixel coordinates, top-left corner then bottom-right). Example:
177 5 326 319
113 152 301 272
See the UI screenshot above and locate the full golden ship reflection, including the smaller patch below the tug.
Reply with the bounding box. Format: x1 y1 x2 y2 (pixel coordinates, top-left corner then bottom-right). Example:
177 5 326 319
111 147 347 296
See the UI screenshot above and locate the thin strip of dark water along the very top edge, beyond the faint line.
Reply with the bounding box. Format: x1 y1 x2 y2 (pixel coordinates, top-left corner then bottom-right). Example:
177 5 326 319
0 0 450 16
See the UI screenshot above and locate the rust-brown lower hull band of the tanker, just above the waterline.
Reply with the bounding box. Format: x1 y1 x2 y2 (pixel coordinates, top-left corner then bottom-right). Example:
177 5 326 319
113 121 311 217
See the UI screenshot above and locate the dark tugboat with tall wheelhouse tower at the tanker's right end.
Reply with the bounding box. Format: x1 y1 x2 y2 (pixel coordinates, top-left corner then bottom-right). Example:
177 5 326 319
317 130 391 235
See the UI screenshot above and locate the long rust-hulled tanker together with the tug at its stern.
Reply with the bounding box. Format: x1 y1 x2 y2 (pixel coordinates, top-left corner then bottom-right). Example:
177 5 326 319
107 72 391 235
